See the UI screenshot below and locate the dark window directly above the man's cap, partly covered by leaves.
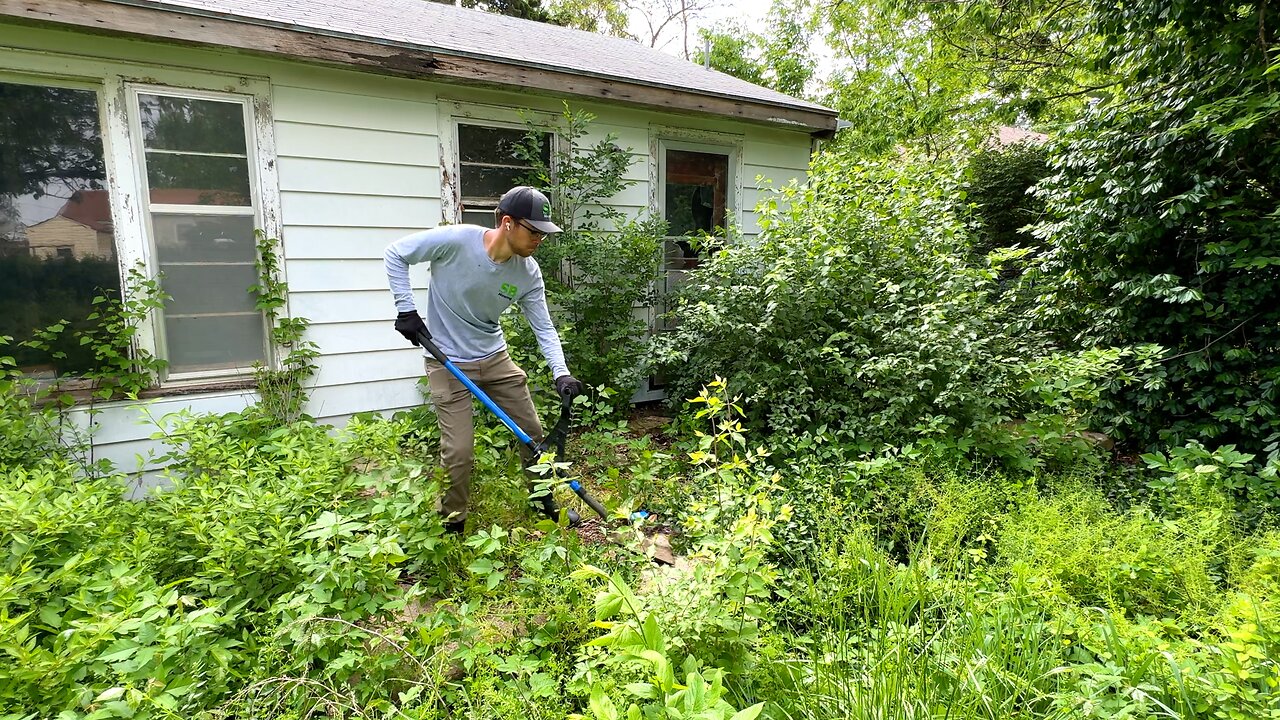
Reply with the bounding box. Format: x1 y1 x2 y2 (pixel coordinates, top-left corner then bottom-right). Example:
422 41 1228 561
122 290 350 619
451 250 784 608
458 123 552 228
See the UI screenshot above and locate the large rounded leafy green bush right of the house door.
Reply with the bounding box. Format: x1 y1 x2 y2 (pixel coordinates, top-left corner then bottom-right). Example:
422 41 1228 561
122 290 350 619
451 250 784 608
655 148 1153 465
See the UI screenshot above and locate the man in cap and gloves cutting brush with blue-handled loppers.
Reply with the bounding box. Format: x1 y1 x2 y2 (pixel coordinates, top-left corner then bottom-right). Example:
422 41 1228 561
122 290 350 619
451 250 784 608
384 186 582 533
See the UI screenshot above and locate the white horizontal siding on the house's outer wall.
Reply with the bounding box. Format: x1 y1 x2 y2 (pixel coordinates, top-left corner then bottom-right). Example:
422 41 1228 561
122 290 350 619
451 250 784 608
0 19 809 469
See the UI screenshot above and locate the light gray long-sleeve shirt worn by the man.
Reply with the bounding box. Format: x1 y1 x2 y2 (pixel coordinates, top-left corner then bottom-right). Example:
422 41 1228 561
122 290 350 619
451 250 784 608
384 225 568 378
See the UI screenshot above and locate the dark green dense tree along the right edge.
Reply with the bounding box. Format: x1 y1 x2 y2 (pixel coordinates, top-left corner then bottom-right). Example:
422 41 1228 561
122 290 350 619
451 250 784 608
1028 0 1280 454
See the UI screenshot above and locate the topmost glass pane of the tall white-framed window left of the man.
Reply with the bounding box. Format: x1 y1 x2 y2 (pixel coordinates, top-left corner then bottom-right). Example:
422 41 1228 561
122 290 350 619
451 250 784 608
138 95 246 155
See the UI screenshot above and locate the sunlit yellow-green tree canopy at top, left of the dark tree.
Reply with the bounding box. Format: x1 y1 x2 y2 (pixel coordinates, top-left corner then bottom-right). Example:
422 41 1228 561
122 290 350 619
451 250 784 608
818 0 1108 156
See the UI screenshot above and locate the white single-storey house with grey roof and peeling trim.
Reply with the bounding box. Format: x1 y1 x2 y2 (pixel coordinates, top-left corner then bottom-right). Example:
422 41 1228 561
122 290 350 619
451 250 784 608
0 0 836 465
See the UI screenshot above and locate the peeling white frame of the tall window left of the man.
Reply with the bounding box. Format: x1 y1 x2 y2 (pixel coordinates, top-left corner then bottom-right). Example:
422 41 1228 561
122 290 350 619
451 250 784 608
122 82 279 387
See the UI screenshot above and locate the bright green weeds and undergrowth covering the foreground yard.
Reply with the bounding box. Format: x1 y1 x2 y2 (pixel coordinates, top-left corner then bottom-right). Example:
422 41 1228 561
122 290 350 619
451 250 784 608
0 382 1280 720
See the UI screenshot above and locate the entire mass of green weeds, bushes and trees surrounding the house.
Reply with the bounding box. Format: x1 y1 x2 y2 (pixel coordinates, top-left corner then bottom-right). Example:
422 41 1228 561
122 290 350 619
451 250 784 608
0 0 1280 720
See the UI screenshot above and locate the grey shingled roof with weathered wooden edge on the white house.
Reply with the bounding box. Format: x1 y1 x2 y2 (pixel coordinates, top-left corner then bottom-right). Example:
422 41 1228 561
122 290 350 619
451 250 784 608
0 0 836 132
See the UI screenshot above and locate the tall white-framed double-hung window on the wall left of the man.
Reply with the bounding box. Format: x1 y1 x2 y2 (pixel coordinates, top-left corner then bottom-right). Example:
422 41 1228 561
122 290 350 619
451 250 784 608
134 91 266 378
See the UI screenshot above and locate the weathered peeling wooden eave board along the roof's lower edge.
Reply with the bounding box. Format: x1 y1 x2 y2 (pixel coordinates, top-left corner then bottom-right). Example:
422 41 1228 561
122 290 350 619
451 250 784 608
0 0 836 133
